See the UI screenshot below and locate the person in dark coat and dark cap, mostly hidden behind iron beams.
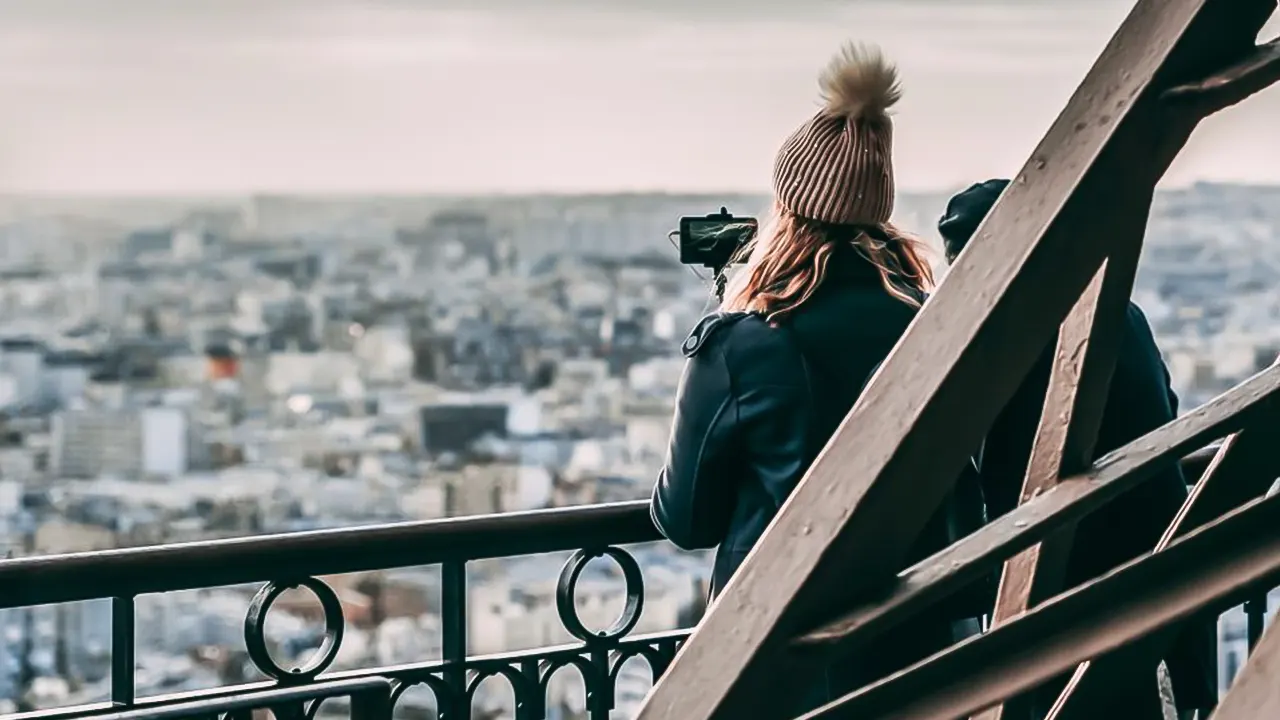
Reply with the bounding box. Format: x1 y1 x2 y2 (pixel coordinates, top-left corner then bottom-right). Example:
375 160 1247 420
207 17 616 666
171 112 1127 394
938 179 1217 719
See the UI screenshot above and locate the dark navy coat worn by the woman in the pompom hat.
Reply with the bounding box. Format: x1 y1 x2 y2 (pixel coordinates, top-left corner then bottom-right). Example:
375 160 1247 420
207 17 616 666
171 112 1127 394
652 247 983 592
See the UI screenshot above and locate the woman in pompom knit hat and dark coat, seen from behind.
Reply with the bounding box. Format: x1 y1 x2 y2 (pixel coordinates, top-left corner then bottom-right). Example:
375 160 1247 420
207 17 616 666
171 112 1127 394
652 41 983 700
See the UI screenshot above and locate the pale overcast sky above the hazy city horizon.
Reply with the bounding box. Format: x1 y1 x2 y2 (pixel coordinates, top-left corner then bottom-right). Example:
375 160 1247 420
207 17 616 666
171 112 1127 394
0 0 1280 193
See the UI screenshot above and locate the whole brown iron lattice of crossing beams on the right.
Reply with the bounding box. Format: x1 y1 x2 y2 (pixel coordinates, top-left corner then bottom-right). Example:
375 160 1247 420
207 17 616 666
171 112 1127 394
639 0 1280 720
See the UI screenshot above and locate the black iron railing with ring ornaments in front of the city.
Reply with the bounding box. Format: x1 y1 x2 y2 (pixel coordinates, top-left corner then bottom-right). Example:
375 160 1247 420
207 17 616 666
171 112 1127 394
0 501 689 720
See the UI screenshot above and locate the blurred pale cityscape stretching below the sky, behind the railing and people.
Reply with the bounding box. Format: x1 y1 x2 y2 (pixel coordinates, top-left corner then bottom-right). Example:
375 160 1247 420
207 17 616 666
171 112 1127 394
0 184 1280 719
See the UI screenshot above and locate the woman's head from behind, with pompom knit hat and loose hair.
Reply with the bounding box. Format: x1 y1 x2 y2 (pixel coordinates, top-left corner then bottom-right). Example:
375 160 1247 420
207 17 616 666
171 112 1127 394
724 45 933 322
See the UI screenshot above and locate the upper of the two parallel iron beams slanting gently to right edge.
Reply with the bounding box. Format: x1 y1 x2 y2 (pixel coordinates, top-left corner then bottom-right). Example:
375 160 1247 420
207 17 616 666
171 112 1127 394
795 368 1280 653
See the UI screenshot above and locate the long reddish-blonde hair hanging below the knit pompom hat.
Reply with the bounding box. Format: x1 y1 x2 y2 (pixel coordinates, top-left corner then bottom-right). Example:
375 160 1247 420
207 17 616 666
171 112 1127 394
722 208 933 323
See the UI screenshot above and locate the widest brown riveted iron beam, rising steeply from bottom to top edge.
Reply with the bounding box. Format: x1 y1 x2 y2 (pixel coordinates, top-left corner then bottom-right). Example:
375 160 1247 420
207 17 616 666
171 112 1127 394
639 0 1262 720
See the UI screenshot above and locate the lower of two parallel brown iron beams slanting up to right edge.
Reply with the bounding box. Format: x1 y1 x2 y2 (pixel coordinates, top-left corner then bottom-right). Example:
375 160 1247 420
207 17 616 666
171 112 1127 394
804 486 1280 720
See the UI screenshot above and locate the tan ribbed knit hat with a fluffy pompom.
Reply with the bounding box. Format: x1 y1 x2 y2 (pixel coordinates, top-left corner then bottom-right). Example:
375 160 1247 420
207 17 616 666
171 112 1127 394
773 44 902 225
